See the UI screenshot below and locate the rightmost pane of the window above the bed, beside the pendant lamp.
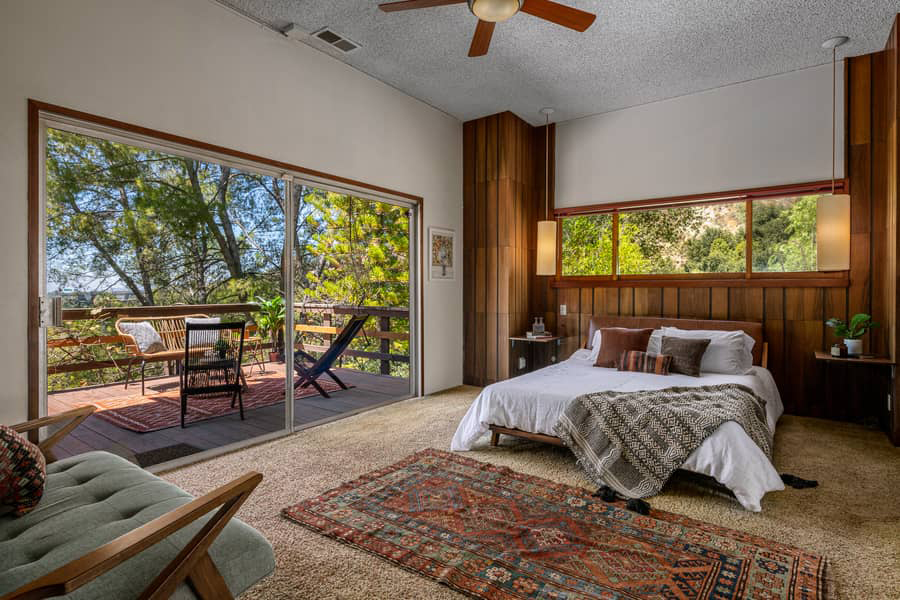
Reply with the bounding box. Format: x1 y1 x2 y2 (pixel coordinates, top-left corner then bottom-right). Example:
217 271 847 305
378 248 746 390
753 196 818 273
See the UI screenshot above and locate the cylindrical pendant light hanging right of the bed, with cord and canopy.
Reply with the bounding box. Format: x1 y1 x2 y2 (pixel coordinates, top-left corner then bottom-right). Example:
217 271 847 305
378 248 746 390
816 36 850 271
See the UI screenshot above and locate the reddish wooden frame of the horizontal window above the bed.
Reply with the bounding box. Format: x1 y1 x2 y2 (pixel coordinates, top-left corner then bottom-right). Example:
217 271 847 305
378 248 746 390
551 178 850 288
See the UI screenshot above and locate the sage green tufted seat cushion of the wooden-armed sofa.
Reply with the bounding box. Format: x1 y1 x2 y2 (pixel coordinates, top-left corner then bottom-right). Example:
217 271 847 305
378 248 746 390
0 452 275 599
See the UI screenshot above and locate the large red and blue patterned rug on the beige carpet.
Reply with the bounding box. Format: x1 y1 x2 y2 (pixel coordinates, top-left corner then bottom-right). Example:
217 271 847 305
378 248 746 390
283 449 829 600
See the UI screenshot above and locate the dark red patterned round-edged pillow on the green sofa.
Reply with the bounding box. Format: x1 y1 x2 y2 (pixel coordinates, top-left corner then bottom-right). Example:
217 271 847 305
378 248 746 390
0 425 47 517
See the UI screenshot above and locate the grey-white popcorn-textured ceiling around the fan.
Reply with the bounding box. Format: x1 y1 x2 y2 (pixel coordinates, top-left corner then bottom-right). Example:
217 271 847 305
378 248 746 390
218 0 900 124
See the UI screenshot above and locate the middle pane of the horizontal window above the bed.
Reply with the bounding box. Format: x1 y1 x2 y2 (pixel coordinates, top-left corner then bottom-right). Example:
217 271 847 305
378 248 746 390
619 202 747 275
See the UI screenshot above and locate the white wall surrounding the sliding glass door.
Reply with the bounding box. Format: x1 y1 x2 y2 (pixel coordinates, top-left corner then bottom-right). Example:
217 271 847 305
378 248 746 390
0 0 462 423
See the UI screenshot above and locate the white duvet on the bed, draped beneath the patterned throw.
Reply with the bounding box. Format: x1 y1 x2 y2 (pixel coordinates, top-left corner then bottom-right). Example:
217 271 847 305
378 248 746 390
450 350 784 512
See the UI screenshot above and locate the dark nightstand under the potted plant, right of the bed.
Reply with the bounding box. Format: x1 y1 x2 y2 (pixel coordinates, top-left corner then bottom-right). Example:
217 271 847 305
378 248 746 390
816 352 897 436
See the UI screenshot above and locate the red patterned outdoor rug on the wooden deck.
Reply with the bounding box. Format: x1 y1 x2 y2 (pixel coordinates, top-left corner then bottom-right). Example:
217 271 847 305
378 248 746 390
91 377 352 433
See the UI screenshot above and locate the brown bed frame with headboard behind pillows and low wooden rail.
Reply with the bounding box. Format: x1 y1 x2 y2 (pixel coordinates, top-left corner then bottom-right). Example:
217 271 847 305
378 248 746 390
488 317 769 446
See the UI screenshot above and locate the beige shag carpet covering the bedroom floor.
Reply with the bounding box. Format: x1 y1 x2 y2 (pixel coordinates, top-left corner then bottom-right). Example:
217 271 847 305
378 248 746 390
165 387 900 599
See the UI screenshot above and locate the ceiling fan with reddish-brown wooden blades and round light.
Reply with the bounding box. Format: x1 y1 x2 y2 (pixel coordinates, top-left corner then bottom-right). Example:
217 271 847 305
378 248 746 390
378 0 597 56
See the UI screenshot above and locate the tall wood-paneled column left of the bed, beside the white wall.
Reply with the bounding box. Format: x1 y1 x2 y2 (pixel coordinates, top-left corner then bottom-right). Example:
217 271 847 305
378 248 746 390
463 112 546 385
